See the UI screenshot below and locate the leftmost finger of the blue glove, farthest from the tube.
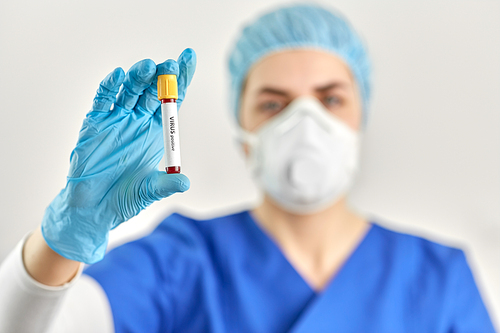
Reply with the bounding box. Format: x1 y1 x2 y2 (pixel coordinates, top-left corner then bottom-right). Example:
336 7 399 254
90 67 125 112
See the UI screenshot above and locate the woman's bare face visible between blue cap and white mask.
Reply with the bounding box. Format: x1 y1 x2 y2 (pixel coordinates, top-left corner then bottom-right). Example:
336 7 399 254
240 50 361 132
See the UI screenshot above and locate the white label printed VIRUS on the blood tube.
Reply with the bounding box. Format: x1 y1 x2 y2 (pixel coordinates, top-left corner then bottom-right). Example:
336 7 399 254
161 103 181 167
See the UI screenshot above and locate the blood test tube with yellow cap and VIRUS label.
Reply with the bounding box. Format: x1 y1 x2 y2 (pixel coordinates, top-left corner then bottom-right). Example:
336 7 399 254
158 74 181 173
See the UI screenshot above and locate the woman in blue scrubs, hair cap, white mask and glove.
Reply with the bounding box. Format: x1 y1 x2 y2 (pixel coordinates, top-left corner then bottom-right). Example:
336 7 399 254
0 5 494 333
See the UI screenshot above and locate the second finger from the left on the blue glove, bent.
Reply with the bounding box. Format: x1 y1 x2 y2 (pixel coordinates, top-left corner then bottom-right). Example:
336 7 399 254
116 59 156 110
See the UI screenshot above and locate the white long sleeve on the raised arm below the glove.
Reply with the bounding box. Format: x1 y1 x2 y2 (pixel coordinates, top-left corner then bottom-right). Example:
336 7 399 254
0 236 114 333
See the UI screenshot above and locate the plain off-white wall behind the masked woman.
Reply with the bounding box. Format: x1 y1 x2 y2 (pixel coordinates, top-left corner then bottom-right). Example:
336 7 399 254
0 0 500 322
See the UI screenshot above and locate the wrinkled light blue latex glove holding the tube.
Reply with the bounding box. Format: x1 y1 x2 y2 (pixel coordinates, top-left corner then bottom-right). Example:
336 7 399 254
42 49 196 264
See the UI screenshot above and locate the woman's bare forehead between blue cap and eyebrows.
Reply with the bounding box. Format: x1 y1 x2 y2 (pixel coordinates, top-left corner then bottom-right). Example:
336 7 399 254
246 49 353 90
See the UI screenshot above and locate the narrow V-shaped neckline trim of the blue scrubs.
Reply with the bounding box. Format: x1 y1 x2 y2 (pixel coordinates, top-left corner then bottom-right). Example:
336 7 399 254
242 211 376 296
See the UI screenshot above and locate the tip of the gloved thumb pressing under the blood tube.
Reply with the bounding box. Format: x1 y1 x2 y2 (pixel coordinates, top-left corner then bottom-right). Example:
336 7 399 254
150 171 190 200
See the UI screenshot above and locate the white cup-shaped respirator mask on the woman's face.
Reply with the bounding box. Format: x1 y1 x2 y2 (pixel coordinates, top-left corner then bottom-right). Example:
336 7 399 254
239 96 359 214
